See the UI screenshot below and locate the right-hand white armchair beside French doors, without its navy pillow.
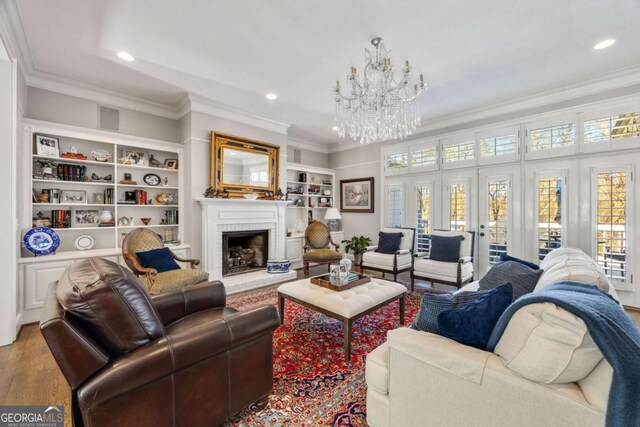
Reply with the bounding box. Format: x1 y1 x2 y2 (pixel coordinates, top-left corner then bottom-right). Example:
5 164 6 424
411 230 476 290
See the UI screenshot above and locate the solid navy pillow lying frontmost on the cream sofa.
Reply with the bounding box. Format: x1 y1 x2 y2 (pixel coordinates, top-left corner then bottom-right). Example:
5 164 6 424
436 283 513 350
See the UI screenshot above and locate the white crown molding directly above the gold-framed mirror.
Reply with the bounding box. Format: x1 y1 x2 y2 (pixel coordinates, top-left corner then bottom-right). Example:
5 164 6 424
188 93 290 135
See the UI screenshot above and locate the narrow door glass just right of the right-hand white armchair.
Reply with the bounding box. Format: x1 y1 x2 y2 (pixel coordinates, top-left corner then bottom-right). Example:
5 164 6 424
487 179 509 265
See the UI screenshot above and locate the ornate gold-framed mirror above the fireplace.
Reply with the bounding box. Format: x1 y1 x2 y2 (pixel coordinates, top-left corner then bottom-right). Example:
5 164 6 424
209 131 280 197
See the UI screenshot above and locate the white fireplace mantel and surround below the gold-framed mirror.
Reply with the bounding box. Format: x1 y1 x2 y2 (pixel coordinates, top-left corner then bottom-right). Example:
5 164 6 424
196 197 291 286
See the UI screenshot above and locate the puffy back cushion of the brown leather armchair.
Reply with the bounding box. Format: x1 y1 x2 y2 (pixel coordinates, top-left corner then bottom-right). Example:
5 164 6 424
56 258 165 356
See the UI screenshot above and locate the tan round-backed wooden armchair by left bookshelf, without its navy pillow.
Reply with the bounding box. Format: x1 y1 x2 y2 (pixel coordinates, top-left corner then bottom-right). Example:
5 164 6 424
122 228 209 294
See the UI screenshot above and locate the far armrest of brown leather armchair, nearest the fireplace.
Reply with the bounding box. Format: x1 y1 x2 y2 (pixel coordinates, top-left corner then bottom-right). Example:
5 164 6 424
152 280 227 326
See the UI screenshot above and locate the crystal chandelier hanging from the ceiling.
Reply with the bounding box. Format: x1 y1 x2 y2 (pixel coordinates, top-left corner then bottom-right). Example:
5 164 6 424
333 37 426 144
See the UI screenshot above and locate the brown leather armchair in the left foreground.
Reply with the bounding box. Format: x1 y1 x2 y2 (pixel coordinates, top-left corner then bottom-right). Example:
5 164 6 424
40 258 279 427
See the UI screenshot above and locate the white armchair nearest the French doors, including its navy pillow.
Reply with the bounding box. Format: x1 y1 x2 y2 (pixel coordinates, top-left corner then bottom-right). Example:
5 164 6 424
411 230 475 290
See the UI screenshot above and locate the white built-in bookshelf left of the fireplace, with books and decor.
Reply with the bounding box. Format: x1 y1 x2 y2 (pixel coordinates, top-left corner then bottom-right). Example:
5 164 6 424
21 120 183 257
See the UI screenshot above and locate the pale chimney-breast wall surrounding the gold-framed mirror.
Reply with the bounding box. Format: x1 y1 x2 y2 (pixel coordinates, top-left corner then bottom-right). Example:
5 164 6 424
179 111 287 258
